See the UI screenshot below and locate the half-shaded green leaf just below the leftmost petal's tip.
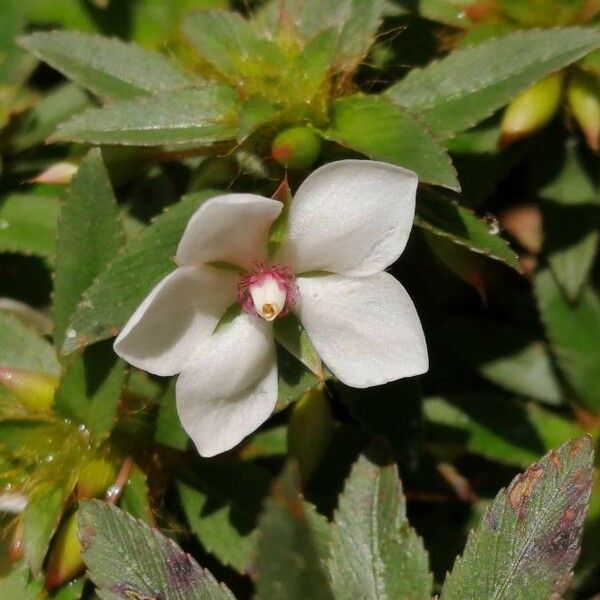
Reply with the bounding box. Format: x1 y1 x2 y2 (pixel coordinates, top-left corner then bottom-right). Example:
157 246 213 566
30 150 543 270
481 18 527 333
54 342 125 443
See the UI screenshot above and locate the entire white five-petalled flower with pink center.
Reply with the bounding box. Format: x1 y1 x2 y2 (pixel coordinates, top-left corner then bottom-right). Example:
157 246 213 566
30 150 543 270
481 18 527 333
115 160 428 456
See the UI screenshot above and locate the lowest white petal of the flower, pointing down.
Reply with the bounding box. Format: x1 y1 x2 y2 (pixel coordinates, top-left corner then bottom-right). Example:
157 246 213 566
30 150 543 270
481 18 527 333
176 313 277 456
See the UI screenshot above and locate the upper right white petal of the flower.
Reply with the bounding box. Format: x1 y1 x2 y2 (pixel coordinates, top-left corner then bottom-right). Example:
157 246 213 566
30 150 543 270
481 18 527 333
278 160 417 275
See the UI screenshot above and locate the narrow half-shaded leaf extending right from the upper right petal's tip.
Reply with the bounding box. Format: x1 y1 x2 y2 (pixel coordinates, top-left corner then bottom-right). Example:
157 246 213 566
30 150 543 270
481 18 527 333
415 190 520 271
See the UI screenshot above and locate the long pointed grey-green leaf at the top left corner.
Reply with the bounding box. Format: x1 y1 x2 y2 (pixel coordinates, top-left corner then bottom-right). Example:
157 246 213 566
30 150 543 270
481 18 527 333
19 31 190 100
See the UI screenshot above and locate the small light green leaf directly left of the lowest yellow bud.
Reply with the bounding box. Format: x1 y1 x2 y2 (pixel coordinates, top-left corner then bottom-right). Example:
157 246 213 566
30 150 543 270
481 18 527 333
23 481 70 576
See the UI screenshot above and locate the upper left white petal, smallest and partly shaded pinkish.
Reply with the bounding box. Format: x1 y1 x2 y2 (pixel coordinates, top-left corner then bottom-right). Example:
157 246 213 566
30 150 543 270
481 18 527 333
175 194 283 269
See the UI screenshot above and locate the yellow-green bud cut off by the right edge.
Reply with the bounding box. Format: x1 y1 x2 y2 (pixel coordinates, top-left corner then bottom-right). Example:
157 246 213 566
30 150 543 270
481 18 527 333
567 71 600 152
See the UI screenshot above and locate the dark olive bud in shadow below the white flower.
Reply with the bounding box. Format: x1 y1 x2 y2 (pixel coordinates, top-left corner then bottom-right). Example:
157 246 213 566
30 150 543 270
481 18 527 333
288 384 333 482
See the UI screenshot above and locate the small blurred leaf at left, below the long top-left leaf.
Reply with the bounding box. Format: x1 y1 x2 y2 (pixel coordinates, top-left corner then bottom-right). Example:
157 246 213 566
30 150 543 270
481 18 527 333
10 83 93 152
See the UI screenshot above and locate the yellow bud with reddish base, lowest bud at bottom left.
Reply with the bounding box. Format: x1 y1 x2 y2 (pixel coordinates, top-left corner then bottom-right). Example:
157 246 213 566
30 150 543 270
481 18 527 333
46 513 84 590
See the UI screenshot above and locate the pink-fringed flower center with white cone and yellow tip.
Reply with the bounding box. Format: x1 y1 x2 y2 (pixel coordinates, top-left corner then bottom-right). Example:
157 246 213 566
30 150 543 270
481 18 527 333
238 262 298 321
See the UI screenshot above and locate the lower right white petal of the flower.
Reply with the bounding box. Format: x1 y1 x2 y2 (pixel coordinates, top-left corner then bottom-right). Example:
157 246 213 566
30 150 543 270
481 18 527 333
294 273 429 388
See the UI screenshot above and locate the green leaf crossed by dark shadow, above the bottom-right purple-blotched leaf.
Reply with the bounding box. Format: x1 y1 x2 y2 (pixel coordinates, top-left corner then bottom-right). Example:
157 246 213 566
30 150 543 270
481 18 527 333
423 392 582 466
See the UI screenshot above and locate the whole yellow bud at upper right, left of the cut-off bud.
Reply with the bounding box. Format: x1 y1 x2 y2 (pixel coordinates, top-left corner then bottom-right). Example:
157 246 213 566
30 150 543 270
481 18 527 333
500 73 563 147
